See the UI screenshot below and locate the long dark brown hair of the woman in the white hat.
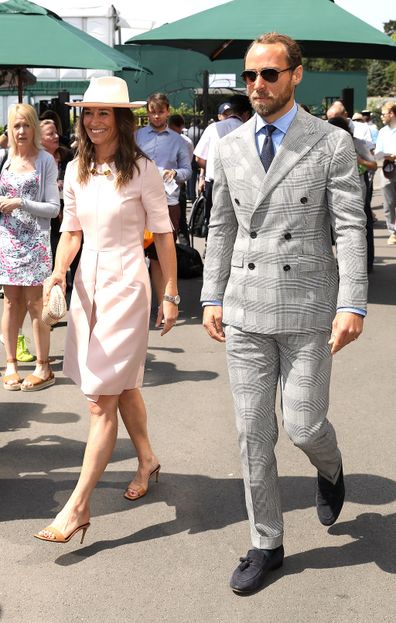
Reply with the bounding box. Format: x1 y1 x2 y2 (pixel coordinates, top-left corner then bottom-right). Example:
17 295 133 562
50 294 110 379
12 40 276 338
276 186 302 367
77 108 147 188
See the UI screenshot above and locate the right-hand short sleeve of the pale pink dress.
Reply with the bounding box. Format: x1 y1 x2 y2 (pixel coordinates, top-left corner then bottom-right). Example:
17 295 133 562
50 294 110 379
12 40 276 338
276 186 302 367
139 159 173 234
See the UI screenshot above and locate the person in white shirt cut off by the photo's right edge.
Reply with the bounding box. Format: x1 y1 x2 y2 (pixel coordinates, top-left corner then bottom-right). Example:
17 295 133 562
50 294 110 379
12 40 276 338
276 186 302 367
374 102 396 244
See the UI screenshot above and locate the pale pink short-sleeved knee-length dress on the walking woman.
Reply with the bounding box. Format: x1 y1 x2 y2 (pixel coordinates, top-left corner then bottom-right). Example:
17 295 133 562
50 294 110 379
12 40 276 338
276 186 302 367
61 158 172 400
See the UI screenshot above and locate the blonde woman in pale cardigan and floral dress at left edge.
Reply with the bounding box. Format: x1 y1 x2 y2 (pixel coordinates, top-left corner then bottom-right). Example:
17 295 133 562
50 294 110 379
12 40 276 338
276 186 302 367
0 104 59 391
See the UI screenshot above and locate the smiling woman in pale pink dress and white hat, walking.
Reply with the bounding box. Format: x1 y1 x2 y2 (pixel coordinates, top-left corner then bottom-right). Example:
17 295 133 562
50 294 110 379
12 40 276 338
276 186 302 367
35 77 179 542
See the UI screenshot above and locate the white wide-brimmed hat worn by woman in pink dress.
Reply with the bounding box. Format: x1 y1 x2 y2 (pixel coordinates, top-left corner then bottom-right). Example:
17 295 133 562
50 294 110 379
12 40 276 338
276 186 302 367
67 76 138 108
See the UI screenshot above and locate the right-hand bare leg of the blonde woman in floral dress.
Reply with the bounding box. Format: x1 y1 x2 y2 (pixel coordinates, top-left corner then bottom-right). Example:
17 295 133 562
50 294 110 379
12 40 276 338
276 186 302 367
24 286 50 385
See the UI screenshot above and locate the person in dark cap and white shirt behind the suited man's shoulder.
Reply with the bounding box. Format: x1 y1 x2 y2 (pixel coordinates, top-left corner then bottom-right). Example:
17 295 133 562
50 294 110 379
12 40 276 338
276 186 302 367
194 95 252 236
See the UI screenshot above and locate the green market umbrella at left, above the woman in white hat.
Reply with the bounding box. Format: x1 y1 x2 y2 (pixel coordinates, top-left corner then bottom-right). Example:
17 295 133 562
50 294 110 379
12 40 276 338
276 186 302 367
0 0 148 101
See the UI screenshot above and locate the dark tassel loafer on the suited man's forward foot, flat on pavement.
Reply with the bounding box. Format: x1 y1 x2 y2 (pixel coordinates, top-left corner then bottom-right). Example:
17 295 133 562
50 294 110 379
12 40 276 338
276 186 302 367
230 545 285 595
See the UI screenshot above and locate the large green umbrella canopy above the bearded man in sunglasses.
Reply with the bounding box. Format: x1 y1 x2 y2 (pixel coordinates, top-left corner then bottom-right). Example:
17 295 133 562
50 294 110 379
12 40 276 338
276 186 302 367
126 0 396 60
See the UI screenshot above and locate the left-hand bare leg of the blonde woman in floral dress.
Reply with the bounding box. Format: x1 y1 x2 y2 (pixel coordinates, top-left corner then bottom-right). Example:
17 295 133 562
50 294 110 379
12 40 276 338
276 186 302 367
1 285 23 385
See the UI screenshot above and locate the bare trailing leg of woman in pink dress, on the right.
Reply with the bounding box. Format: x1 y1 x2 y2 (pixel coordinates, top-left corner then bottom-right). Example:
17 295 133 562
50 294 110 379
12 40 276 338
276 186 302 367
118 389 159 497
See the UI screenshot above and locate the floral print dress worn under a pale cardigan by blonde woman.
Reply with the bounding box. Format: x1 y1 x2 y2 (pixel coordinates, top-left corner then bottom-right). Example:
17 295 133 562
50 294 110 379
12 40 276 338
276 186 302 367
0 169 52 286
